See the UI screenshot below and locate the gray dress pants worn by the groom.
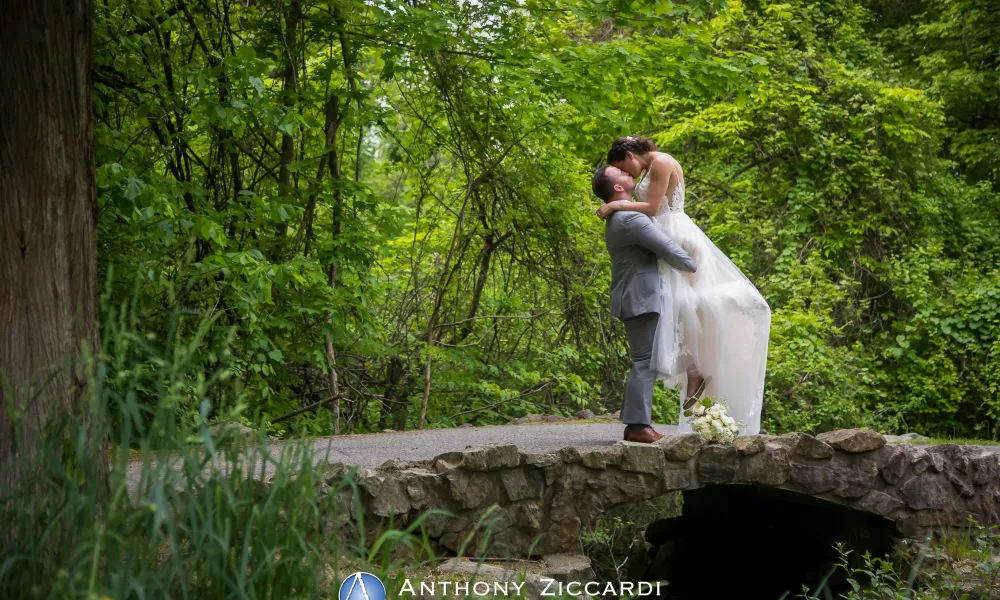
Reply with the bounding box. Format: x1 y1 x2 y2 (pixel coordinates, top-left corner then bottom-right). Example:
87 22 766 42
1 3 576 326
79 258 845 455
622 313 660 425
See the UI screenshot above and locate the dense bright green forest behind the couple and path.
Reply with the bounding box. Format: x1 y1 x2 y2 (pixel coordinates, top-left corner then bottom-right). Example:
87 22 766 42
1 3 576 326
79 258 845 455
93 0 1000 438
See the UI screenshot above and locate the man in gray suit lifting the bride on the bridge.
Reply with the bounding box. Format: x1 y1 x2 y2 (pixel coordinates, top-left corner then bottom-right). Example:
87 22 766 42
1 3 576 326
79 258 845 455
590 167 697 444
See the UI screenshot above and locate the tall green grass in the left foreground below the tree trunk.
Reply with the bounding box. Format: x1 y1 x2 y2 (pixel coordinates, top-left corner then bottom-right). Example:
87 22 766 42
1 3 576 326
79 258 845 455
0 282 446 600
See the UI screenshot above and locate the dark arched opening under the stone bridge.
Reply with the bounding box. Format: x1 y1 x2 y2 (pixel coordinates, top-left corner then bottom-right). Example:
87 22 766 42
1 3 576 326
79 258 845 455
645 485 901 600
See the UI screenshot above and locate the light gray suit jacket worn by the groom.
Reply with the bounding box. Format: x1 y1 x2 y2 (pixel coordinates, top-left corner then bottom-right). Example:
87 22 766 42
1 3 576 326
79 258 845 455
604 210 698 320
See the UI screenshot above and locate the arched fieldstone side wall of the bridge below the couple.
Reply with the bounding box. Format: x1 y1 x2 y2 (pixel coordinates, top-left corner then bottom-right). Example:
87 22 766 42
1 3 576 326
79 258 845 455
312 429 1000 556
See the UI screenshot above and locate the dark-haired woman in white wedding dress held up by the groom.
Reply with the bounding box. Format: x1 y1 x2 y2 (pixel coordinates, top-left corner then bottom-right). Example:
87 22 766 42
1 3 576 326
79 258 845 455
598 137 771 435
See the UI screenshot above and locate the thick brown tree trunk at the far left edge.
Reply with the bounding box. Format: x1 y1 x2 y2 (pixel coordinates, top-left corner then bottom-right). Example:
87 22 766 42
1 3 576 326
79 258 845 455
0 0 106 487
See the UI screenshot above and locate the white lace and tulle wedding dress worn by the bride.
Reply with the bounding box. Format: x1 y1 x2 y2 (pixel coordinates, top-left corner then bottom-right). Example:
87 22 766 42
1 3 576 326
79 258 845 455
635 166 771 435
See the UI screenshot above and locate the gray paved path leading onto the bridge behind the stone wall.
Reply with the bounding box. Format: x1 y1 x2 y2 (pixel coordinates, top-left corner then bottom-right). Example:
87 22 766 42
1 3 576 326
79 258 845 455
290 422 677 467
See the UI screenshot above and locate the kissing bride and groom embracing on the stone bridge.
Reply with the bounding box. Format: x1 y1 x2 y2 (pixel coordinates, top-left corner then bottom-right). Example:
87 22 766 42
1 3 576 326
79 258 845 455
591 137 771 443
